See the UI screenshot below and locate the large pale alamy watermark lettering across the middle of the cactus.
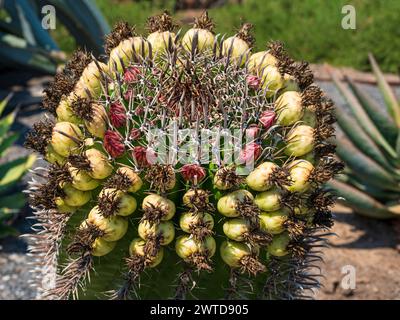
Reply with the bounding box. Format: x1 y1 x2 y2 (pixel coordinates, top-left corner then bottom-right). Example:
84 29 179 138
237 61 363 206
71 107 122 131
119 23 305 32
146 125 262 174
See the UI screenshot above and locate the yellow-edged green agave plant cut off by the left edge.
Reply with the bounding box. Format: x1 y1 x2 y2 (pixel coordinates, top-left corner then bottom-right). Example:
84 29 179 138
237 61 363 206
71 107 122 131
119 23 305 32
0 95 36 239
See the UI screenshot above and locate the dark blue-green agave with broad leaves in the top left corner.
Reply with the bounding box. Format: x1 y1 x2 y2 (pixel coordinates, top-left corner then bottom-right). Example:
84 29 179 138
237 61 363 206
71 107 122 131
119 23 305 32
0 0 109 74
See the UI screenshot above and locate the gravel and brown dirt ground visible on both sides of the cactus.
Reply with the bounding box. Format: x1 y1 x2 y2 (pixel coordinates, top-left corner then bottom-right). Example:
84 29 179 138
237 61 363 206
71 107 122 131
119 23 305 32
0 82 400 299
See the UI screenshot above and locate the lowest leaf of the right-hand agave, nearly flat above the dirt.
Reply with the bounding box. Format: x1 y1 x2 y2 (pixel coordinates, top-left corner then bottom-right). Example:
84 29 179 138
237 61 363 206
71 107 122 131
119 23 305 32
326 180 395 219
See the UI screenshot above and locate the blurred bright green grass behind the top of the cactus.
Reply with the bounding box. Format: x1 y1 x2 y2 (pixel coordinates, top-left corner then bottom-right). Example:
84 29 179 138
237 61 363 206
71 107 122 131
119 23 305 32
56 0 400 72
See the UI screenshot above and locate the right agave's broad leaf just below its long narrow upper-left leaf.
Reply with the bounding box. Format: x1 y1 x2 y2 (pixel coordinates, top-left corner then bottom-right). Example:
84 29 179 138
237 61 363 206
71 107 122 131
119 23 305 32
335 109 393 171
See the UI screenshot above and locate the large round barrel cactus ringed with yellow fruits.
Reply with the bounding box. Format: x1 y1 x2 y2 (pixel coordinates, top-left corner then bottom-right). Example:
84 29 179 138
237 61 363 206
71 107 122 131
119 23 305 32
26 13 342 299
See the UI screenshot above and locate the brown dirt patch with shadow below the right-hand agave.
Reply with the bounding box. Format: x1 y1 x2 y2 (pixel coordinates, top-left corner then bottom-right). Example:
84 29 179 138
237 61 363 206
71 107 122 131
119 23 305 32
316 206 400 300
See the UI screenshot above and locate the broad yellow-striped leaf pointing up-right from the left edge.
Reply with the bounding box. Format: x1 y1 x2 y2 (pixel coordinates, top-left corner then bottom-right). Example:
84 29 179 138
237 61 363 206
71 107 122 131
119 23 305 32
0 155 36 192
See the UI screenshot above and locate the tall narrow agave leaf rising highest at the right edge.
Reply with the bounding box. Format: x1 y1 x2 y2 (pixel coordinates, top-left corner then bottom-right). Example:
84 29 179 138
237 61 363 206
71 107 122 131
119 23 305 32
368 53 400 127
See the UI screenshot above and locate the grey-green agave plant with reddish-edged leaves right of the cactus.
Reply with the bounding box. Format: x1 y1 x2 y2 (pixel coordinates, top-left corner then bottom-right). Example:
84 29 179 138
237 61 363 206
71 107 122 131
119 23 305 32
328 54 400 219
